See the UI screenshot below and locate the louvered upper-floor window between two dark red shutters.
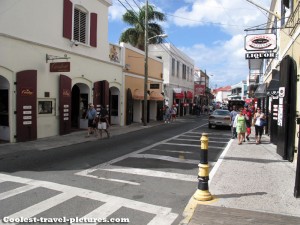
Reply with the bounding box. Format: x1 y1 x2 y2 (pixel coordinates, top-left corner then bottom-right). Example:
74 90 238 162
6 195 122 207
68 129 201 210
73 8 87 44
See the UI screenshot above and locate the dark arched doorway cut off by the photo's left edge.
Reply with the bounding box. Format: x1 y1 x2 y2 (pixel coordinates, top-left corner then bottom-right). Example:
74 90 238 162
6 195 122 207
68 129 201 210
0 75 10 143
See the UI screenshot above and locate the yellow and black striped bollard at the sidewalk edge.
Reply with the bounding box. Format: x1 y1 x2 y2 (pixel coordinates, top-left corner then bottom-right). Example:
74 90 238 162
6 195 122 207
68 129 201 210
194 133 212 201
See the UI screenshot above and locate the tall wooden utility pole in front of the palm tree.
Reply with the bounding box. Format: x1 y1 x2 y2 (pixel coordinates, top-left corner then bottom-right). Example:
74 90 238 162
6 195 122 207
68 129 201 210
143 0 148 126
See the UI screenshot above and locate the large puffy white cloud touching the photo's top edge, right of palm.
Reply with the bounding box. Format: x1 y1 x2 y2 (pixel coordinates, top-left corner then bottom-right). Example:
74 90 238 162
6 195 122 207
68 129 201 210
171 0 271 35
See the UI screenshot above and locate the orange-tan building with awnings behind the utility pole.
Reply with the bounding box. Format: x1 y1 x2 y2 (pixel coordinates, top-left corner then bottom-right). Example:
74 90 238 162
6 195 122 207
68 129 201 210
121 43 164 125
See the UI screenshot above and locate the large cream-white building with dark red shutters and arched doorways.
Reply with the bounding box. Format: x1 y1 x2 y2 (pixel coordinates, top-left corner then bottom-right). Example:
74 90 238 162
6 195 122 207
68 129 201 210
0 0 124 142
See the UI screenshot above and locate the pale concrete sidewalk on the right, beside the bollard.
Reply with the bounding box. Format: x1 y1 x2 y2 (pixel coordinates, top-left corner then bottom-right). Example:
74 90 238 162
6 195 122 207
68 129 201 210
185 130 300 225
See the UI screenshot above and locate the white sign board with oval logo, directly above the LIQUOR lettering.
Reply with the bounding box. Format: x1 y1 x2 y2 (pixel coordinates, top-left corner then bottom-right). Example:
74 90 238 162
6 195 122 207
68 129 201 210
245 34 277 51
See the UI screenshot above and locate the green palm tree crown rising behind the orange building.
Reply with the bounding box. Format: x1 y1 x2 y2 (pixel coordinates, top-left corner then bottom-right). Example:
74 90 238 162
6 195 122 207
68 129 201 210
120 5 166 50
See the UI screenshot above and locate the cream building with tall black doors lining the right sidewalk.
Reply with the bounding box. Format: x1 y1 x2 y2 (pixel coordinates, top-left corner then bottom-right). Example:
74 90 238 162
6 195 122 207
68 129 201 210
250 0 300 197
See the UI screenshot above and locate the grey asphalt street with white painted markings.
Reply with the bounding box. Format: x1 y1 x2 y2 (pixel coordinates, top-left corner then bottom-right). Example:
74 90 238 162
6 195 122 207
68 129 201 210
0 117 231 225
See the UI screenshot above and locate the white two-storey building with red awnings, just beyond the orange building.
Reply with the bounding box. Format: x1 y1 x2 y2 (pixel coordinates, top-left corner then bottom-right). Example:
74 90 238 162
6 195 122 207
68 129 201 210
149 43 194 116
